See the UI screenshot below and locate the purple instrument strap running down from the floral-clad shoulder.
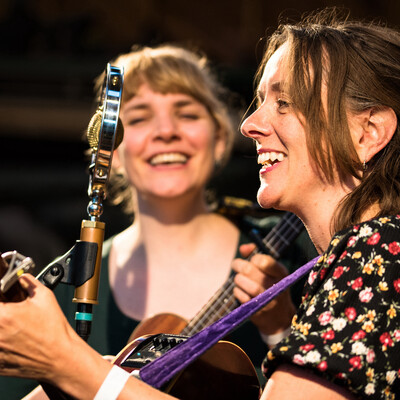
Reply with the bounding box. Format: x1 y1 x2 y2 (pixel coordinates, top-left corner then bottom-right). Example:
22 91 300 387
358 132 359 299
139 256 319 389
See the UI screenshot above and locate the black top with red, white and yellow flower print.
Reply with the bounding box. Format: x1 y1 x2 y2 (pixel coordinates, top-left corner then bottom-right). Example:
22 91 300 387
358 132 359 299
263 215 400 399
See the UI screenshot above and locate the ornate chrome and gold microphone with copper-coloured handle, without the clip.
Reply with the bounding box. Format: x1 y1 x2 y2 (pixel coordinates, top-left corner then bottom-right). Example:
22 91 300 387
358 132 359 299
72 64 123 341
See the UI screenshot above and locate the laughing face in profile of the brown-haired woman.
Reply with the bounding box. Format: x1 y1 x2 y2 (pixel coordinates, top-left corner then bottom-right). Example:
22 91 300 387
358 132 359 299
242 44 344 214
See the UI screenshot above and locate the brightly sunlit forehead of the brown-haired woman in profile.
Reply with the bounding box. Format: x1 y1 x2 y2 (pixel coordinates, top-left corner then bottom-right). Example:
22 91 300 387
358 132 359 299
258 44 288 94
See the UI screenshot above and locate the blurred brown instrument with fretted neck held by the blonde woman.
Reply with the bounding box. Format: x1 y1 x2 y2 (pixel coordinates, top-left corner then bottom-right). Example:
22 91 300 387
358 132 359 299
128 212 304 343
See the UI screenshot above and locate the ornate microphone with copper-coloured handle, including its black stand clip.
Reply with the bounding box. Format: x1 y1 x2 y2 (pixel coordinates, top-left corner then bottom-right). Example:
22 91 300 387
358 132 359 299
37 64 123 400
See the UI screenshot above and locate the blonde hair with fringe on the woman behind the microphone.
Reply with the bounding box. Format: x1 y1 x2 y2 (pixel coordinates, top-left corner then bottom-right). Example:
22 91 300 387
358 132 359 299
96 45 235 212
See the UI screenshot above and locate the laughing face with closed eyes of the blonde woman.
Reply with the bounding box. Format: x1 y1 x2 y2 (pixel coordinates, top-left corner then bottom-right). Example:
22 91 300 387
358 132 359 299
117 83 224 203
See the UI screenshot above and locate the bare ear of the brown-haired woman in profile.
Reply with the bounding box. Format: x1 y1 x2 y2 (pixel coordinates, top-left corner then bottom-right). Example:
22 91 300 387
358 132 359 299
350 107 397 162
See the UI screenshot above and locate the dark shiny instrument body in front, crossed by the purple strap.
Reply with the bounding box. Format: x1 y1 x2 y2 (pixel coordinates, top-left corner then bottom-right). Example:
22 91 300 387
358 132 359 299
113 334 261 400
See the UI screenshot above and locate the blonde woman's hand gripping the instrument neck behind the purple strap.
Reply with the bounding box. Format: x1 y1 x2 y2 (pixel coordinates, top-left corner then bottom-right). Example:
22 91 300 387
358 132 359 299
232 244 296 335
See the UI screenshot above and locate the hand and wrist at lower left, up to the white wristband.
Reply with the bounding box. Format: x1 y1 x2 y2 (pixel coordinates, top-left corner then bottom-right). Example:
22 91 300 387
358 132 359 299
0 274 115 400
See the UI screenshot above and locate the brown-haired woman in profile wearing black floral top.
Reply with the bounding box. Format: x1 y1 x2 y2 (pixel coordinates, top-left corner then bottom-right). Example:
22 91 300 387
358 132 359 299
238 11 400 399
